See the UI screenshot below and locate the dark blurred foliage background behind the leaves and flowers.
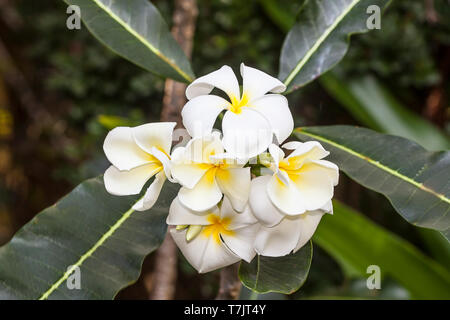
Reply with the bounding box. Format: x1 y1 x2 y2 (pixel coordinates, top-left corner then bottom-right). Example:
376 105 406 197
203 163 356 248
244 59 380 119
0 0 450 299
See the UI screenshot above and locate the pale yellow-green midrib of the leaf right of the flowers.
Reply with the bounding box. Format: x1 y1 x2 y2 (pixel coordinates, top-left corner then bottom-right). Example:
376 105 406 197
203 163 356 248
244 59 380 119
295 128 450 204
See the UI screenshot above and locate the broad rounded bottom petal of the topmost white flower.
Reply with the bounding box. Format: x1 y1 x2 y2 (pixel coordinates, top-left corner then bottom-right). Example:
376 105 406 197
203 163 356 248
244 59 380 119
222 108 273 158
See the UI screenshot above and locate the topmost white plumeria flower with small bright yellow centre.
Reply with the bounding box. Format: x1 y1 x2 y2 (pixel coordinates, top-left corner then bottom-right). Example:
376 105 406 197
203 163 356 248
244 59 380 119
182 63 294 158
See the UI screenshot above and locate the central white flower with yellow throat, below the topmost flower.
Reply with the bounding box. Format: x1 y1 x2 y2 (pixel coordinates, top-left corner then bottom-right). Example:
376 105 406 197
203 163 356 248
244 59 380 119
171 132 251 211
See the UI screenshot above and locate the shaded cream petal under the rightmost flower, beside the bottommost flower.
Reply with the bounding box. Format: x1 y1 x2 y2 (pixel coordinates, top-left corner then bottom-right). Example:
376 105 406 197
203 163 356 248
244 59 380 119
255 217 301 257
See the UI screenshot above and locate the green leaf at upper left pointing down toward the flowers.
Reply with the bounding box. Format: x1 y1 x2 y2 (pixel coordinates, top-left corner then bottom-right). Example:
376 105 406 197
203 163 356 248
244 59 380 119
64 0 194 82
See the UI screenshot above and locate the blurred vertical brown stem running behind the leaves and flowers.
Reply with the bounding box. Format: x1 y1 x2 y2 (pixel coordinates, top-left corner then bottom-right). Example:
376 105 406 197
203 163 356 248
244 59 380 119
150 0 198 300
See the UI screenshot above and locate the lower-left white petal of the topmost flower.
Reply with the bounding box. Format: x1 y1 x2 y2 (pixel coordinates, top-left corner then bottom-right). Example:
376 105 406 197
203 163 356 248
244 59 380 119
181 95 229 138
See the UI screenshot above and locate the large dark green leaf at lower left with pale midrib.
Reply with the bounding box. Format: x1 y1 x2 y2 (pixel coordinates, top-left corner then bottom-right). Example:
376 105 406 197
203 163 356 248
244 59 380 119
0 177 177 300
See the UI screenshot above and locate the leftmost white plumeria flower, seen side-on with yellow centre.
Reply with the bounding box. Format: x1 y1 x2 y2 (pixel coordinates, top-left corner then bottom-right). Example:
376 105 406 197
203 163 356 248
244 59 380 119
103 122 176 211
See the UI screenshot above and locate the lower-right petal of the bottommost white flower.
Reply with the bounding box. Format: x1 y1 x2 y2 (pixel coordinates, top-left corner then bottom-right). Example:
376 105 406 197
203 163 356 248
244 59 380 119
221 224 260 262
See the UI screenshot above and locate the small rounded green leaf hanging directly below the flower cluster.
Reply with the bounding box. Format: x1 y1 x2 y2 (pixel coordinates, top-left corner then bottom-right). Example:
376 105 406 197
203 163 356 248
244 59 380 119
239 241 312 294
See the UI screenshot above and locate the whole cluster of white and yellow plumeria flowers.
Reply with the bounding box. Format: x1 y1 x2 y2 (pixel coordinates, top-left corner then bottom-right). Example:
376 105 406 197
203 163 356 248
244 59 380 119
104 64 339 273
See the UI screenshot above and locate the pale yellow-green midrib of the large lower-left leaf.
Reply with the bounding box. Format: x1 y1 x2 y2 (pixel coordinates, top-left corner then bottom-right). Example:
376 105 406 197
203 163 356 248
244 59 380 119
39 199 140 300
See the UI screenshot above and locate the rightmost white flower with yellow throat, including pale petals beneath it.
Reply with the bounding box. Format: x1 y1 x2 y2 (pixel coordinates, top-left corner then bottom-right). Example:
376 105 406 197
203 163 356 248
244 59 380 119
249 141 339 257
